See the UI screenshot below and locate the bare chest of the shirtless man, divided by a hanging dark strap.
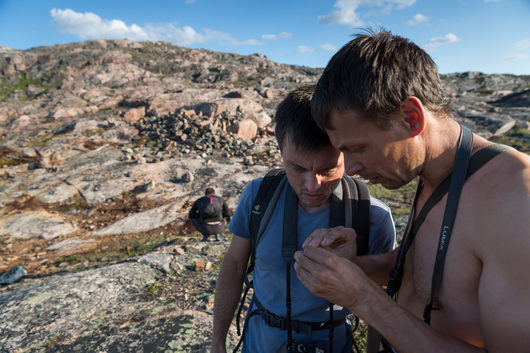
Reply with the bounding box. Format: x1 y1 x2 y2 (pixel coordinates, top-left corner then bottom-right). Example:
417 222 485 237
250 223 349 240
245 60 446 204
398 203 481 330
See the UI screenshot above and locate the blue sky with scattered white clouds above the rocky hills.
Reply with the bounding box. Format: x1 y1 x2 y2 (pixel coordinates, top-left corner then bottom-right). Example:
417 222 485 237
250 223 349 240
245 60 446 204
0 0 530 75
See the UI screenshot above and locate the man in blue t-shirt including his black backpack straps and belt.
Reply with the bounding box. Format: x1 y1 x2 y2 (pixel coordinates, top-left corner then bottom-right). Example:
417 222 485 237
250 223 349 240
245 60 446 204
211 86 395 353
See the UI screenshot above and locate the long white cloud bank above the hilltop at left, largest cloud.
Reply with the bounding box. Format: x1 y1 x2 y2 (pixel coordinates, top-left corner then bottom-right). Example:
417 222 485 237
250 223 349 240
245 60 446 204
51 9 260 46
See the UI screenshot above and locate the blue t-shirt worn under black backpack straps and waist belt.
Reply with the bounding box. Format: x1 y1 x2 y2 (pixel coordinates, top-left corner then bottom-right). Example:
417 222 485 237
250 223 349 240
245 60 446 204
229 178 396 353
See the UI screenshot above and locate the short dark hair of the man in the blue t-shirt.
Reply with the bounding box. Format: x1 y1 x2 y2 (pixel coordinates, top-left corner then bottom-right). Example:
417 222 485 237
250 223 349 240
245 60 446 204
275 85 331 152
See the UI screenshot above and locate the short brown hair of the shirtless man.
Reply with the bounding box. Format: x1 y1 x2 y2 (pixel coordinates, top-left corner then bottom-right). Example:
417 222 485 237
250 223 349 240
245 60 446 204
311 29 450 129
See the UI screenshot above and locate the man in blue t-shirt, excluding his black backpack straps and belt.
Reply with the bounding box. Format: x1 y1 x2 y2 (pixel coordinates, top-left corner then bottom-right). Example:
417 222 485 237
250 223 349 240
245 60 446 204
211 86 395 353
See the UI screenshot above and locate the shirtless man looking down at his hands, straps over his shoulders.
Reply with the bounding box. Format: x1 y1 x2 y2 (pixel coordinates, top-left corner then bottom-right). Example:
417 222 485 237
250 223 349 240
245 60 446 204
295 32 530 353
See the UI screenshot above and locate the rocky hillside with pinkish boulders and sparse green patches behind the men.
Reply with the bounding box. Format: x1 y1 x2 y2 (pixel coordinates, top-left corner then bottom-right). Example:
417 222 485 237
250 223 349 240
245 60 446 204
0 41 530 352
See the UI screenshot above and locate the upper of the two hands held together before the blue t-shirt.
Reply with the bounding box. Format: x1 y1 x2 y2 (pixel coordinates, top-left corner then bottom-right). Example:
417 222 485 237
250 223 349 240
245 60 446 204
302 226 357 261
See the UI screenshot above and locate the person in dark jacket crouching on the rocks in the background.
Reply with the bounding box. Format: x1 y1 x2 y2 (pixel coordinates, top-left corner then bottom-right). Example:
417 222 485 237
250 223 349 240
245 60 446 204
189 188 231 241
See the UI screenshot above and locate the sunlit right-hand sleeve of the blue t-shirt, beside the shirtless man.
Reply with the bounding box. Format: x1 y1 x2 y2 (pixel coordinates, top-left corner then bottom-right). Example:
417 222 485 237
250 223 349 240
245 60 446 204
368 197 396 254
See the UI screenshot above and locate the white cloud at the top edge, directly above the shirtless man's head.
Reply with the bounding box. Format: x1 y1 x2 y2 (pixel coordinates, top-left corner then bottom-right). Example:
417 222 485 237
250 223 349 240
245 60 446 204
318 0 416 27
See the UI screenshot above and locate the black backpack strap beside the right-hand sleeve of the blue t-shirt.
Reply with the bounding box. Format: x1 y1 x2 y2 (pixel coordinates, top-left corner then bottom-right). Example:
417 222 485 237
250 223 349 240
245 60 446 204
343 176 370 255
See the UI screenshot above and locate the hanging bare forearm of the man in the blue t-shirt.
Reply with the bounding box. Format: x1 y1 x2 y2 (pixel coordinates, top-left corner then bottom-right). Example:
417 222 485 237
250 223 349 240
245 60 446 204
212 262 246 352
